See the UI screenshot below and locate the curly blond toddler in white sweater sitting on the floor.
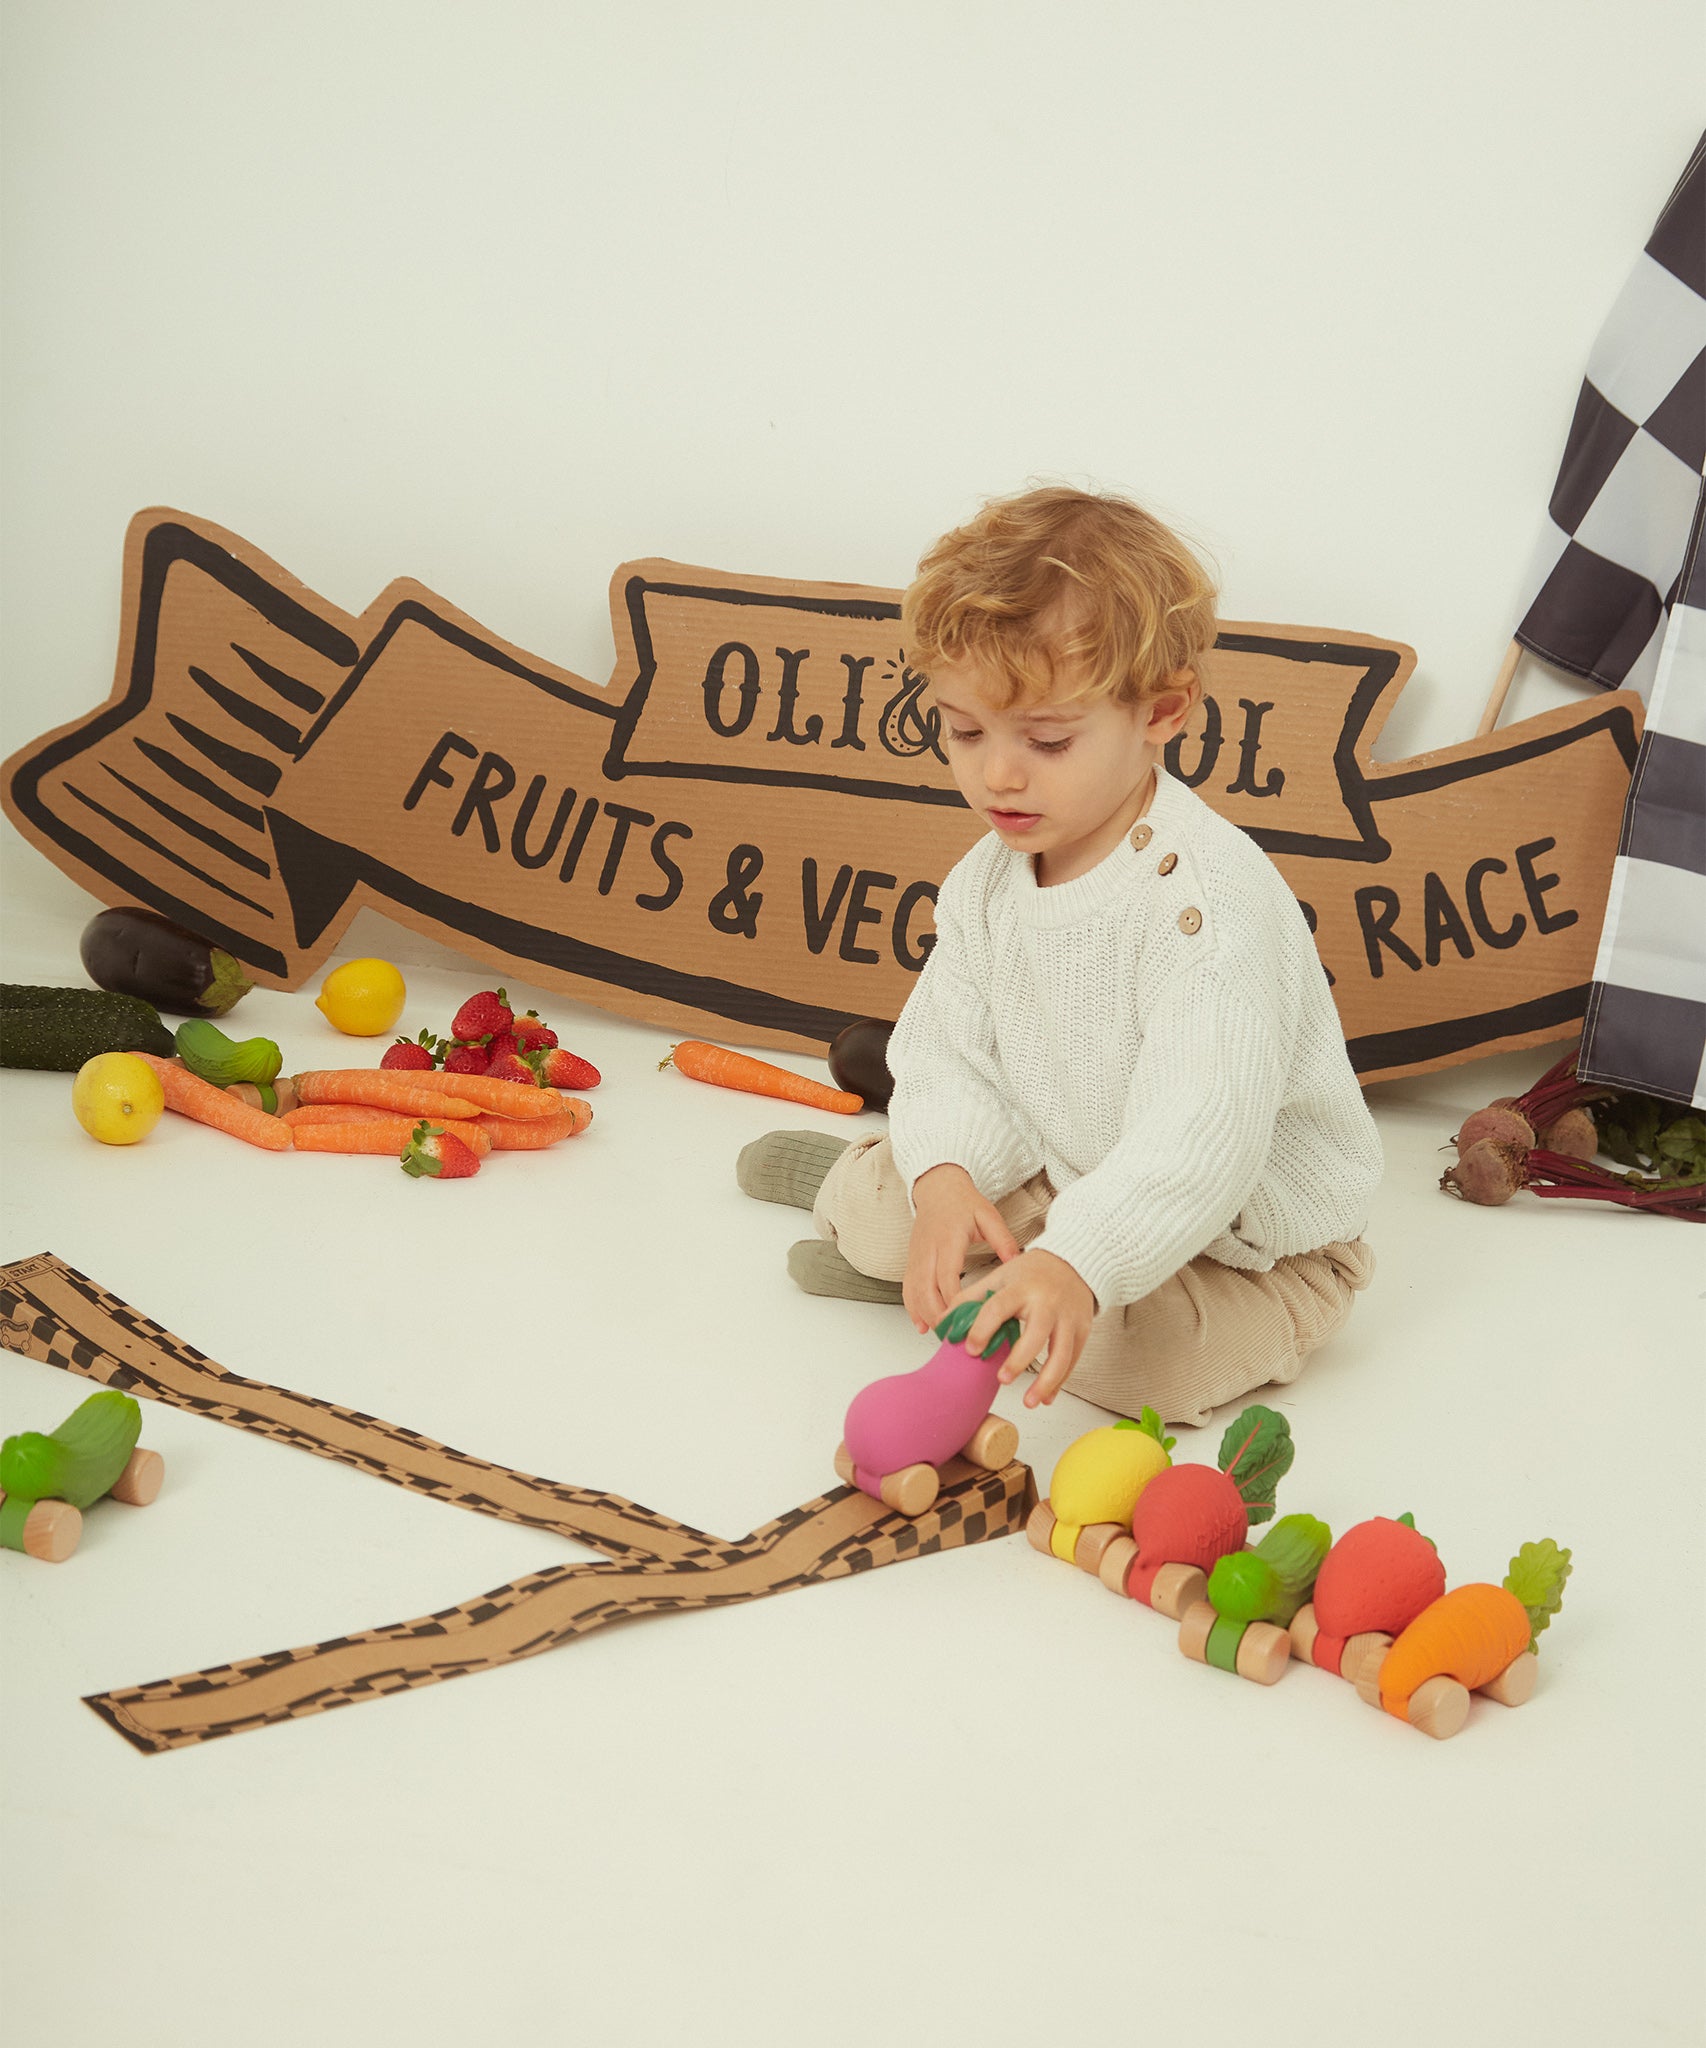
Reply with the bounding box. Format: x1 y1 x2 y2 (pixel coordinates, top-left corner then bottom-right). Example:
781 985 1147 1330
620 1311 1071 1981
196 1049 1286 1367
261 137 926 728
739 487 1380 1423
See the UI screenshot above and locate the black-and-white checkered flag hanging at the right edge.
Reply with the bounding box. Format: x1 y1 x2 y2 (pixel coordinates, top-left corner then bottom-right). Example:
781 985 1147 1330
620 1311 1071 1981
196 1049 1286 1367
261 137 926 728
1516 137 1706 1108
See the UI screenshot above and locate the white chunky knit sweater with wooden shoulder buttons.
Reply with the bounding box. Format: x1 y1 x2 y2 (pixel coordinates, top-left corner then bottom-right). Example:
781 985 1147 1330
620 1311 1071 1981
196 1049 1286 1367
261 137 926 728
889 768 1380 1309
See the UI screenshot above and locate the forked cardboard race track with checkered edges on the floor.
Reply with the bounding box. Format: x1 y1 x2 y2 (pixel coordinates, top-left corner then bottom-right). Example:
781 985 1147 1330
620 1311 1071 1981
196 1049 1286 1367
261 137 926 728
0 1253 1036 1755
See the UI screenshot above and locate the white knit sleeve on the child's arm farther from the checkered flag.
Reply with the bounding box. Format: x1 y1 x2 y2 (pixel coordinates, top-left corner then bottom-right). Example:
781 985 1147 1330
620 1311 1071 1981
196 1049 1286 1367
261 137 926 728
889 860 1042 1202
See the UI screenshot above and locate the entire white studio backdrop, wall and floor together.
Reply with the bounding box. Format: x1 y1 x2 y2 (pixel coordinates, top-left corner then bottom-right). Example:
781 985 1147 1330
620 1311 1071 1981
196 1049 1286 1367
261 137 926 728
0 0 1706 2048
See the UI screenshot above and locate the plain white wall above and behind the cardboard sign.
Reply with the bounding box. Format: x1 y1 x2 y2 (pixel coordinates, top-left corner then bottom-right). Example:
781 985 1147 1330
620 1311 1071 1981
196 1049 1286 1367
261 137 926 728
0 0 1702 929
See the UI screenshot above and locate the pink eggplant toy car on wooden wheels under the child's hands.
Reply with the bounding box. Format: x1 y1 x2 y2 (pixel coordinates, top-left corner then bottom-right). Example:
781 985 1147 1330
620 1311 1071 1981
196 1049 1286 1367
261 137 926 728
836 1288 1018 1516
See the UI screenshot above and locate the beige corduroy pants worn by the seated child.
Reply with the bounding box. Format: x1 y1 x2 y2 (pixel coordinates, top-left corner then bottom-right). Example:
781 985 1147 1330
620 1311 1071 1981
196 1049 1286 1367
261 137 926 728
811 1133 1374 1425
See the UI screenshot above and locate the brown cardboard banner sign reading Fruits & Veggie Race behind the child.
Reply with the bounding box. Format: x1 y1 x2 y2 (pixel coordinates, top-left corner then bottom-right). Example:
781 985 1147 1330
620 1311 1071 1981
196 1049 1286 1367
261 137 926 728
4 510 1638 1079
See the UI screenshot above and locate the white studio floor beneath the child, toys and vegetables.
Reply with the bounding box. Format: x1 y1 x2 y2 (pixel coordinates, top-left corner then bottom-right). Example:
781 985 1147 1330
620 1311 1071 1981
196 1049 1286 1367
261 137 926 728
0 918 1706 2048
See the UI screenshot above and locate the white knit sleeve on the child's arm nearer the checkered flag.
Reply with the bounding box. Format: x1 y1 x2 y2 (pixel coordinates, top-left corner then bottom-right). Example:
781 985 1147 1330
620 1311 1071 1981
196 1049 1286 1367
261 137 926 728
1036 963 1286 1309
